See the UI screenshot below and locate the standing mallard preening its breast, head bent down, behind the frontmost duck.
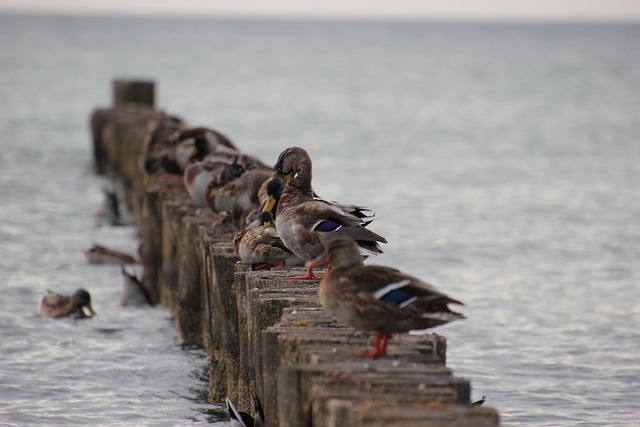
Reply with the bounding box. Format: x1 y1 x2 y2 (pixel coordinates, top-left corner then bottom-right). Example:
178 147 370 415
265 147 387 279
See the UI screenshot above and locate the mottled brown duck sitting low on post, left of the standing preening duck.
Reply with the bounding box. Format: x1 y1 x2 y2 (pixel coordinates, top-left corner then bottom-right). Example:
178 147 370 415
233 211 305 270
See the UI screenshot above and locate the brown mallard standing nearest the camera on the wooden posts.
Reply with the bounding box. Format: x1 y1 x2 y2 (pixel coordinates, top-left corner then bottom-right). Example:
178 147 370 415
310 238 464 356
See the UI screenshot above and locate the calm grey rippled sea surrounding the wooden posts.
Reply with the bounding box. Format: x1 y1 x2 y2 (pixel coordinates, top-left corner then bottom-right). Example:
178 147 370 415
0 15 640 426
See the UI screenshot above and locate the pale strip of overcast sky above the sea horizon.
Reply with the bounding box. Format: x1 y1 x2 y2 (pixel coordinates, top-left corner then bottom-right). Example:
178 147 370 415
0 0 640 21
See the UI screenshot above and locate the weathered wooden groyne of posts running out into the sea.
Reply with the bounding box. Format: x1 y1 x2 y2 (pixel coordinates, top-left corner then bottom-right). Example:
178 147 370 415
91 81 499 427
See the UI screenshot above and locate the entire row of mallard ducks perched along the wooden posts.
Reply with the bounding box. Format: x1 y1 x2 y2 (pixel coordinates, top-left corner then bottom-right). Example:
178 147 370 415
143 118 464 357
